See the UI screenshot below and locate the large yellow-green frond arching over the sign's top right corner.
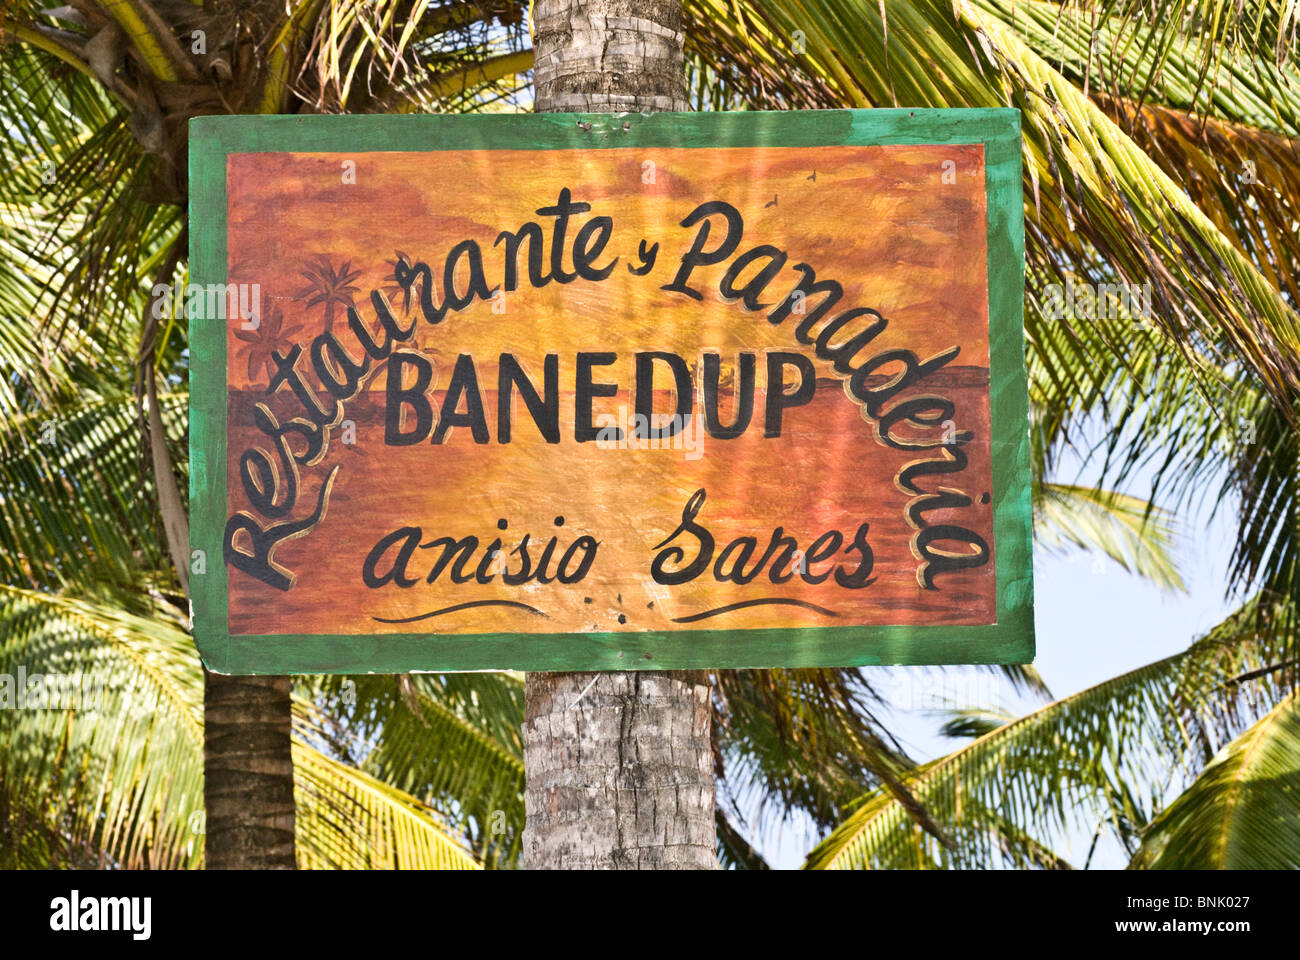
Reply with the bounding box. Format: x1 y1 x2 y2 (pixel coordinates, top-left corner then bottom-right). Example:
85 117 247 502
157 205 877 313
686 0 1300 410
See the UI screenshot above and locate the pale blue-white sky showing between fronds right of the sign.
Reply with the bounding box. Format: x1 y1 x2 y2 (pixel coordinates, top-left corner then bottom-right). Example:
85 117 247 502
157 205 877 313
755 434 1238 869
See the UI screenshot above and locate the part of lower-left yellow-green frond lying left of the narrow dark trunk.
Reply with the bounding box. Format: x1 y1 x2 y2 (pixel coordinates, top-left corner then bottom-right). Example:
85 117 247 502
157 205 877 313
0 585 203 868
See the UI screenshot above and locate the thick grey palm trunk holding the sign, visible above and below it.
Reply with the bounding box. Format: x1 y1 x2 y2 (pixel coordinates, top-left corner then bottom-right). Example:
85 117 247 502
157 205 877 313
524 0 718 869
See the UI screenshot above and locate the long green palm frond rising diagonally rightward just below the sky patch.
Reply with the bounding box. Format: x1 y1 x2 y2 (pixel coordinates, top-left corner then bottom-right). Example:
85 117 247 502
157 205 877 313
806 606 1286 869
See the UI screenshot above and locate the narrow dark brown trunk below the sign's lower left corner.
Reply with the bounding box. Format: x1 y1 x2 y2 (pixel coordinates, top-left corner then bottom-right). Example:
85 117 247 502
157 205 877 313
203 671 295 870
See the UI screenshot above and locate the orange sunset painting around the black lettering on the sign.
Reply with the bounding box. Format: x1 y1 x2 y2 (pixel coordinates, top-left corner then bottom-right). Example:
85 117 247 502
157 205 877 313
226 146 996 635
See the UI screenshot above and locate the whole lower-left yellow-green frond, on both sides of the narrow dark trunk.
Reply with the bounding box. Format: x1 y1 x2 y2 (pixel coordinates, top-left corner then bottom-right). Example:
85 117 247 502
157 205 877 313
0 585 486 869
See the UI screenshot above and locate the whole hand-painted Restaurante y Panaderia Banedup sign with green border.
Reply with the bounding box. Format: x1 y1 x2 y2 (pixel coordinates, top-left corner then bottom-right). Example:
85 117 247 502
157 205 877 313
186 109 1034 674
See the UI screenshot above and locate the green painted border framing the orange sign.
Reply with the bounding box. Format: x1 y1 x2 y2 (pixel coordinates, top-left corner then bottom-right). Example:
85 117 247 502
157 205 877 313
190 109 1034 674
